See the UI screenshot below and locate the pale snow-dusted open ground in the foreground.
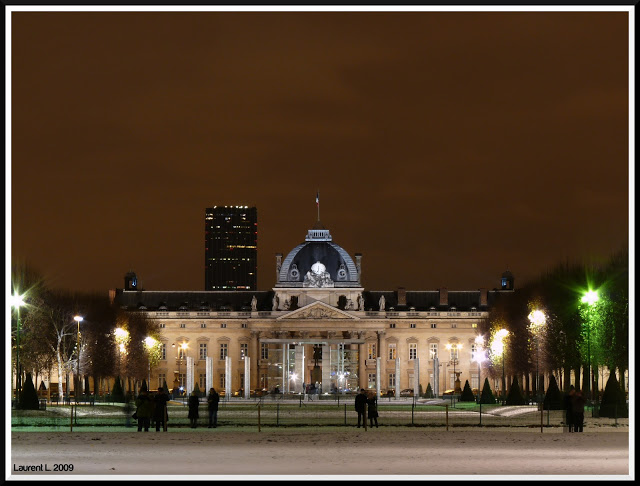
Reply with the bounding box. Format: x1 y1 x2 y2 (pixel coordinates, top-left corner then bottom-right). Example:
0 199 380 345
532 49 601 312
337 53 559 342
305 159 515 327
10 427 629 479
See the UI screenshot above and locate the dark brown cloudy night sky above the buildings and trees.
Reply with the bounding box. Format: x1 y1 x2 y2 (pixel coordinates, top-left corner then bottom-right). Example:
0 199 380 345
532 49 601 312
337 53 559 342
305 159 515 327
11 12 629 292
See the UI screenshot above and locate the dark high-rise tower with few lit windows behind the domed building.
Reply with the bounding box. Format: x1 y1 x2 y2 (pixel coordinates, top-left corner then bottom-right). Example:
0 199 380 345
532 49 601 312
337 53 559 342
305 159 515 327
204 206 258 290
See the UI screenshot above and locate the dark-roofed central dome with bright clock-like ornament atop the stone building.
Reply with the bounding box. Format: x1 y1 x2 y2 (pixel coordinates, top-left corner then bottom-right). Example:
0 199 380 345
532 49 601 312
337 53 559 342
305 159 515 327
276 222 360 287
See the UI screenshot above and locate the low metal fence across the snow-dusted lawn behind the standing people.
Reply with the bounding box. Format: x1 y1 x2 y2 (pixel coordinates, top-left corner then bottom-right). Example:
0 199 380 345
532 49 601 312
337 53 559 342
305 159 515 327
11 397 628 430
